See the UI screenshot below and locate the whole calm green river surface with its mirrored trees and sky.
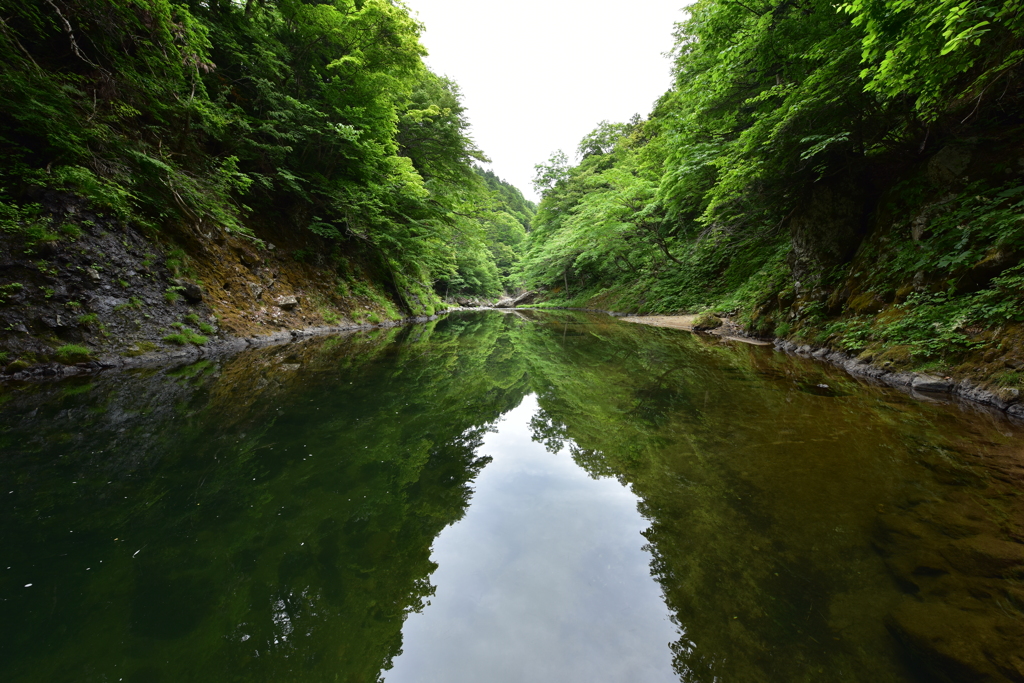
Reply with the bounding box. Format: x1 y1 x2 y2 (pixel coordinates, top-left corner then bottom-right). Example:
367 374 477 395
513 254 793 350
0 312 1024 683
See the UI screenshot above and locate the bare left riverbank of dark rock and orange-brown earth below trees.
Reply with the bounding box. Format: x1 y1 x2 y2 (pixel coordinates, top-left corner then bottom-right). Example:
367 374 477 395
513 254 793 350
0 190 443 381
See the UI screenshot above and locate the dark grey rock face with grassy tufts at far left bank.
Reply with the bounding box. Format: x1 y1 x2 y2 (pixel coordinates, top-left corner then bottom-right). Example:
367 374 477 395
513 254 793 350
0 190 213 375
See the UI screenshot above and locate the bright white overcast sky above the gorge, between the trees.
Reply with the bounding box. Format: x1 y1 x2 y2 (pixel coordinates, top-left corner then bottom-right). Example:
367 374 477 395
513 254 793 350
407 0 689 201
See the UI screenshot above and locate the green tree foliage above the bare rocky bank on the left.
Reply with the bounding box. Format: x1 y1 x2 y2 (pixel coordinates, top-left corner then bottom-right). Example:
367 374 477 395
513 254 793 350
0 0 522 305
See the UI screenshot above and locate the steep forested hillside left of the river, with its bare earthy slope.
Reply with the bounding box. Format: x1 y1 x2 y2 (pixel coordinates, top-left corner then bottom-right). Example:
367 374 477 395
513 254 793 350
0 0 532 370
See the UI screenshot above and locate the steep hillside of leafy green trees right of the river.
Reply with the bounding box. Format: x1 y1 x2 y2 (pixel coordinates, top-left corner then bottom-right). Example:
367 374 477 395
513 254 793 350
522 0 1024 386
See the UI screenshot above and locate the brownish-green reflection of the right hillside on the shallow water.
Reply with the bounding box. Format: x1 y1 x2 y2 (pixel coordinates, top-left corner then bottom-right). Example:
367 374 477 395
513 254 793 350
522 313 1024 682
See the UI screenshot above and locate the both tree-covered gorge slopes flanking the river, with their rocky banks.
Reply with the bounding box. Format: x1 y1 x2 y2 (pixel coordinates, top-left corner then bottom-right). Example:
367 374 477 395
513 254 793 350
0 0 1024 388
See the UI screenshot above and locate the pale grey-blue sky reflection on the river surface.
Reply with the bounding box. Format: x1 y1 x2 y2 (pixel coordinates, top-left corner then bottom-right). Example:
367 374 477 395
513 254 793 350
384 396 679 683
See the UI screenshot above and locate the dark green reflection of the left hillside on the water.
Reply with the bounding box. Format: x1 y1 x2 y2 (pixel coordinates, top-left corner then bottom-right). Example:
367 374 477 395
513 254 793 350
0 323 525 681
